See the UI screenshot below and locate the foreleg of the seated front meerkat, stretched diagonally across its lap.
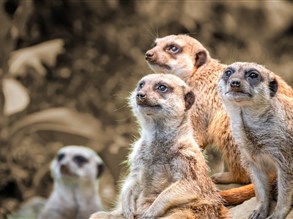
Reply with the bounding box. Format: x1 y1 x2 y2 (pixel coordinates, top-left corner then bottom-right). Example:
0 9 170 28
139 180 198 219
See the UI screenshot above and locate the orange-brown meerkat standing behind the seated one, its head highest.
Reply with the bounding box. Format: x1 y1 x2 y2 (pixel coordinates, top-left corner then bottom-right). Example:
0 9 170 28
145 35 293 184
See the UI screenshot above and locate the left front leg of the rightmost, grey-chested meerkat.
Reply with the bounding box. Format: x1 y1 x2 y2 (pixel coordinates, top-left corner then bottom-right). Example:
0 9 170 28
249 163 271 219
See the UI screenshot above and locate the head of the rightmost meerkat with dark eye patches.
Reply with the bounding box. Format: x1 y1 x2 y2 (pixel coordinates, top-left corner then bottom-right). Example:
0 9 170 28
218 62 278 105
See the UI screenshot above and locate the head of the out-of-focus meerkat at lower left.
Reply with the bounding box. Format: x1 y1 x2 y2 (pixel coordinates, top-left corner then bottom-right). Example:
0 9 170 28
51 146 104 183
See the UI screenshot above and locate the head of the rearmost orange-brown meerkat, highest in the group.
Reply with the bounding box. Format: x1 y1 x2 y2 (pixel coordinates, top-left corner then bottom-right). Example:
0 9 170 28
145 35 210 79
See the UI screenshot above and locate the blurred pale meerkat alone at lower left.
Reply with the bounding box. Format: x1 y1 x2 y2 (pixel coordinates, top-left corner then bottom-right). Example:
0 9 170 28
38 146 104 219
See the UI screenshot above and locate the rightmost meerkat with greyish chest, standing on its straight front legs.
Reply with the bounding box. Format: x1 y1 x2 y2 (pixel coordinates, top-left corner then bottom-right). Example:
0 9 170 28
218 62 293 219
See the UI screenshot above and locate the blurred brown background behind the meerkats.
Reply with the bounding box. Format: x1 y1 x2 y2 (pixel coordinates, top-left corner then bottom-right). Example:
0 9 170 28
0 0 293 215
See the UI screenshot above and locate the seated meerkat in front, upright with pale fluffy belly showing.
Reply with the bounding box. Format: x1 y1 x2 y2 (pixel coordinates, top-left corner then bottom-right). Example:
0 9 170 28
91 74 231 219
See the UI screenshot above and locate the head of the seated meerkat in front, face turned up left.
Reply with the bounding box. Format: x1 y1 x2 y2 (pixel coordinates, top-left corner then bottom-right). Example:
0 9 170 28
130 74 194 118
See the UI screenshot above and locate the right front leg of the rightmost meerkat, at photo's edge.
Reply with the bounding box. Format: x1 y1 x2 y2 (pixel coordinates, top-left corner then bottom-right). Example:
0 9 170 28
268 167 293 219
